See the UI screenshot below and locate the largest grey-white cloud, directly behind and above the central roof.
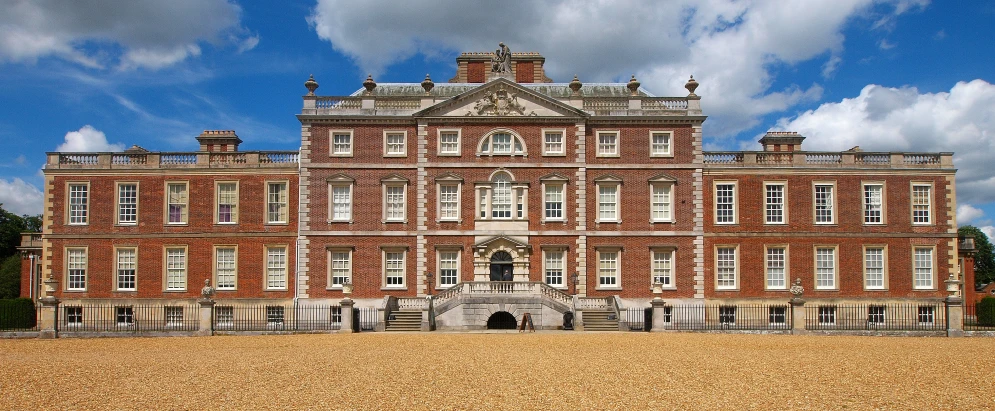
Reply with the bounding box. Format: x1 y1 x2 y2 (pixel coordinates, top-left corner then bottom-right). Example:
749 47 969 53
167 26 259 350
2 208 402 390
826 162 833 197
308 0 916 136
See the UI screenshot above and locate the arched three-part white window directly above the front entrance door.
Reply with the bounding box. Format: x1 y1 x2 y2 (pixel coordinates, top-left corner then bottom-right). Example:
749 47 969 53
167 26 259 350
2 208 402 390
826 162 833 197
476 170 528 220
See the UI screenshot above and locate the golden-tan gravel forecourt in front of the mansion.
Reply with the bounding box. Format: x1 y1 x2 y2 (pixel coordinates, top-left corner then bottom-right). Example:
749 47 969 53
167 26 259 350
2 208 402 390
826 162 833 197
0 333 995 410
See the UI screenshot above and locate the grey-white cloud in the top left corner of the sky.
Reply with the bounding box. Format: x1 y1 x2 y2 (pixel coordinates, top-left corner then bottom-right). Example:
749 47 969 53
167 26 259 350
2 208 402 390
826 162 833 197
0 0 253 69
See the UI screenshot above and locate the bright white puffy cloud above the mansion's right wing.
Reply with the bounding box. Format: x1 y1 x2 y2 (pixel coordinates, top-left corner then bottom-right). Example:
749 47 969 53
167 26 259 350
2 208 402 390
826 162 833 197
776 80 995 204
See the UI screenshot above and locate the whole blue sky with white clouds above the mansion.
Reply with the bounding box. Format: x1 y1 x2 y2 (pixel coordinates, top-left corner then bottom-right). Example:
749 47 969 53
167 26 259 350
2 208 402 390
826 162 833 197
0 0 995 238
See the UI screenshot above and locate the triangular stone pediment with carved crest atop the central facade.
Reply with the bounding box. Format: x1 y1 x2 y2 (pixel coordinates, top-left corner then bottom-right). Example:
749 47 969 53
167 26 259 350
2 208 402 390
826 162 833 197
414 78 587 117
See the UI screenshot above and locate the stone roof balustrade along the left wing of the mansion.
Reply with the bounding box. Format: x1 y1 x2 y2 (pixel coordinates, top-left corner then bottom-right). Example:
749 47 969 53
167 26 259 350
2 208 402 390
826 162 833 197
45 151 300 169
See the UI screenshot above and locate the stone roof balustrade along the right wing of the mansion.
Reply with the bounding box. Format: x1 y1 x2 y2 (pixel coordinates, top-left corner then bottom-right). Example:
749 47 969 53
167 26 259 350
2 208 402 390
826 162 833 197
704 151 953 168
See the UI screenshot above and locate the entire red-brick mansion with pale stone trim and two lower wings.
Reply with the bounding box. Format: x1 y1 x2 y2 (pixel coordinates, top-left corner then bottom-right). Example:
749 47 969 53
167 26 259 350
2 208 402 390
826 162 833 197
24 49 980 329
